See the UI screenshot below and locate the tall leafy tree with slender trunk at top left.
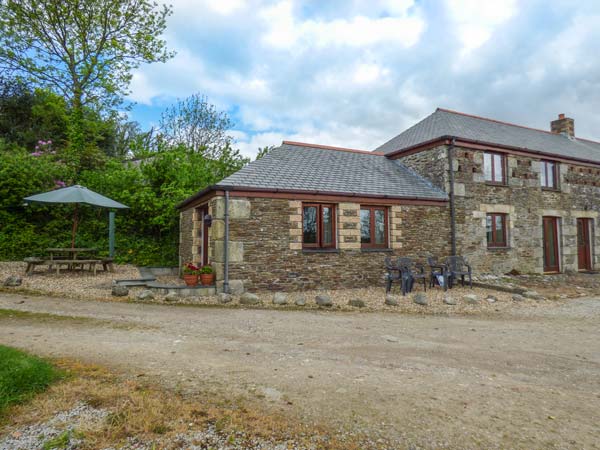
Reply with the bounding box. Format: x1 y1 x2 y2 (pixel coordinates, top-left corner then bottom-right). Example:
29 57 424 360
0 0 173 151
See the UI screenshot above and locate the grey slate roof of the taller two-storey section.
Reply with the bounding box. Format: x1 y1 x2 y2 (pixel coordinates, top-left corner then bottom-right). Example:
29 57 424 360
376 108 600 162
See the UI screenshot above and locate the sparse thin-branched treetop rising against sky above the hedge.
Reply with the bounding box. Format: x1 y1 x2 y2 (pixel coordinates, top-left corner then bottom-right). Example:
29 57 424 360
159 94 233 158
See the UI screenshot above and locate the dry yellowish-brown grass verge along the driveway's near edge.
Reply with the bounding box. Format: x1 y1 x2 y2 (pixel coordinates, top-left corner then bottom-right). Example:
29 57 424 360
0 359 365 450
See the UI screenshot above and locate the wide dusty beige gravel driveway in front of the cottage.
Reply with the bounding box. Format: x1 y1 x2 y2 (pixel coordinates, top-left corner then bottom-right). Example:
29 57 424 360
0 294 600 449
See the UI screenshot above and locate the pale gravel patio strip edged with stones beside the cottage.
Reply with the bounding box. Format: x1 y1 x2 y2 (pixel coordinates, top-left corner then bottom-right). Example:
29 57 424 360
0 262 580 315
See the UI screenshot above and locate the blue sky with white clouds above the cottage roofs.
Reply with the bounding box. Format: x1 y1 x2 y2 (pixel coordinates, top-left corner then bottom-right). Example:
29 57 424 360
128 0 600 156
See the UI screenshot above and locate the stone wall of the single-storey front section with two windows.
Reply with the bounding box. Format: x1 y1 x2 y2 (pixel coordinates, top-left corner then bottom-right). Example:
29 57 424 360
198 197 449 291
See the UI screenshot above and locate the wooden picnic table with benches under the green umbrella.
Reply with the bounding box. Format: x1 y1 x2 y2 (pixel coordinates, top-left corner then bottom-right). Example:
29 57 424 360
25 247 114 275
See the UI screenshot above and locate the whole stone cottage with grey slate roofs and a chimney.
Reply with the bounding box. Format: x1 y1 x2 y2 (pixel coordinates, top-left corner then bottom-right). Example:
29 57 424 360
179 108 600 290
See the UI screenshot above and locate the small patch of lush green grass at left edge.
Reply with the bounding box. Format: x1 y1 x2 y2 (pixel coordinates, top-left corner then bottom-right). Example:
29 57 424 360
0 345 62 417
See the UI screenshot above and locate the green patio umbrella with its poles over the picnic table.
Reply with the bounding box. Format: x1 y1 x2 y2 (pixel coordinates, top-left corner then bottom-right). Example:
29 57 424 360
24 184 129 256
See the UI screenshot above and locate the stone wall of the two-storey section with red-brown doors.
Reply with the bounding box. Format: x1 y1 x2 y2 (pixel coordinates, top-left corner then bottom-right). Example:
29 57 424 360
401 147 600 273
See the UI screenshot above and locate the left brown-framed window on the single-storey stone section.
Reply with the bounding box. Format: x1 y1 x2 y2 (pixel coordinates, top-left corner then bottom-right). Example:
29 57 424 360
302 203 335 248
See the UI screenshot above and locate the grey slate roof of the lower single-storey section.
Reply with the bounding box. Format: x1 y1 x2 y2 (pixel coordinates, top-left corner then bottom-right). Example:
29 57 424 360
215 141 448 200
